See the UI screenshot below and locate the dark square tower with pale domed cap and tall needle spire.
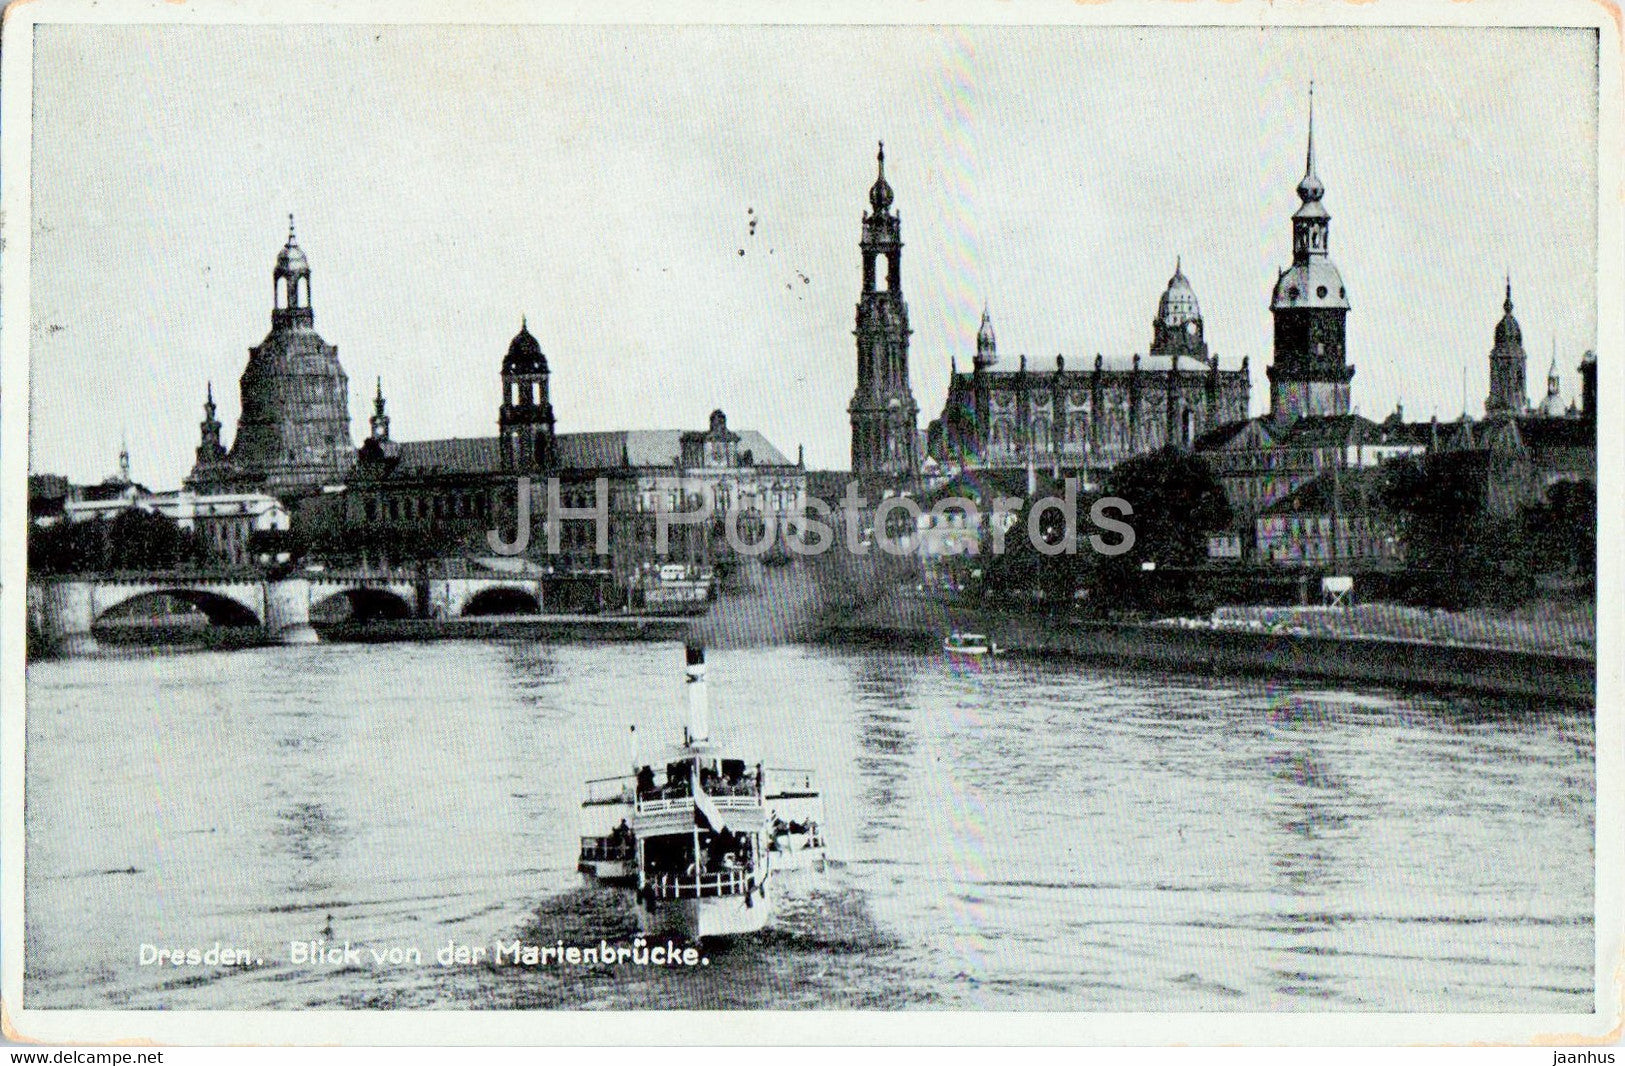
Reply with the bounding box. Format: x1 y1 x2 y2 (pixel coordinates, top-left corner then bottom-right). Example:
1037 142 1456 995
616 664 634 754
1269 85 1354 421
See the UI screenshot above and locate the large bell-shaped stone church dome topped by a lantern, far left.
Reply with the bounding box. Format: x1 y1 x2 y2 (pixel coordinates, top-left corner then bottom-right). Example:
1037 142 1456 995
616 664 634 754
228 215 356 496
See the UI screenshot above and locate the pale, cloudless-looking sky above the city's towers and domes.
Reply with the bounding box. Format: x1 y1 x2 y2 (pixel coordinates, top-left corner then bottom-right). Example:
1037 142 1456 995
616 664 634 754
31 26 1597 488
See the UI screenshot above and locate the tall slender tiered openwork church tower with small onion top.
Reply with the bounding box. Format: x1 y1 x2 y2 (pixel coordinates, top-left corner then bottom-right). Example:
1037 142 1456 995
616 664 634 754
847 145 920 484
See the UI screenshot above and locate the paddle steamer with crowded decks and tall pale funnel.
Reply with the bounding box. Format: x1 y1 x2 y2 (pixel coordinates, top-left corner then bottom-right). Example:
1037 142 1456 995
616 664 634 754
577 645 824 941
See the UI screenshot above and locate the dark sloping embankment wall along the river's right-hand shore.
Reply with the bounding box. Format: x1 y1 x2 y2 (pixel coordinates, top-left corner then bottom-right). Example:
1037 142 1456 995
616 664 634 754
821 595 1596 705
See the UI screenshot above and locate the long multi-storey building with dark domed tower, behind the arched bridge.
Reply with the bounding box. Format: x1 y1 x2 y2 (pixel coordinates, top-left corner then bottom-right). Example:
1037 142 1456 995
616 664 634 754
328 323 806 609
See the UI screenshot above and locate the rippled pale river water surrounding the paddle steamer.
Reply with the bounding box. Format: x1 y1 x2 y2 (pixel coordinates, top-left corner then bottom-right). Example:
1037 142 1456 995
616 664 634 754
24 642 1594 1012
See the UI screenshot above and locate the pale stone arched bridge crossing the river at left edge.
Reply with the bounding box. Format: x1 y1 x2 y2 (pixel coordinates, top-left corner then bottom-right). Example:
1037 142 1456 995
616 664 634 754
28 572 543 655
